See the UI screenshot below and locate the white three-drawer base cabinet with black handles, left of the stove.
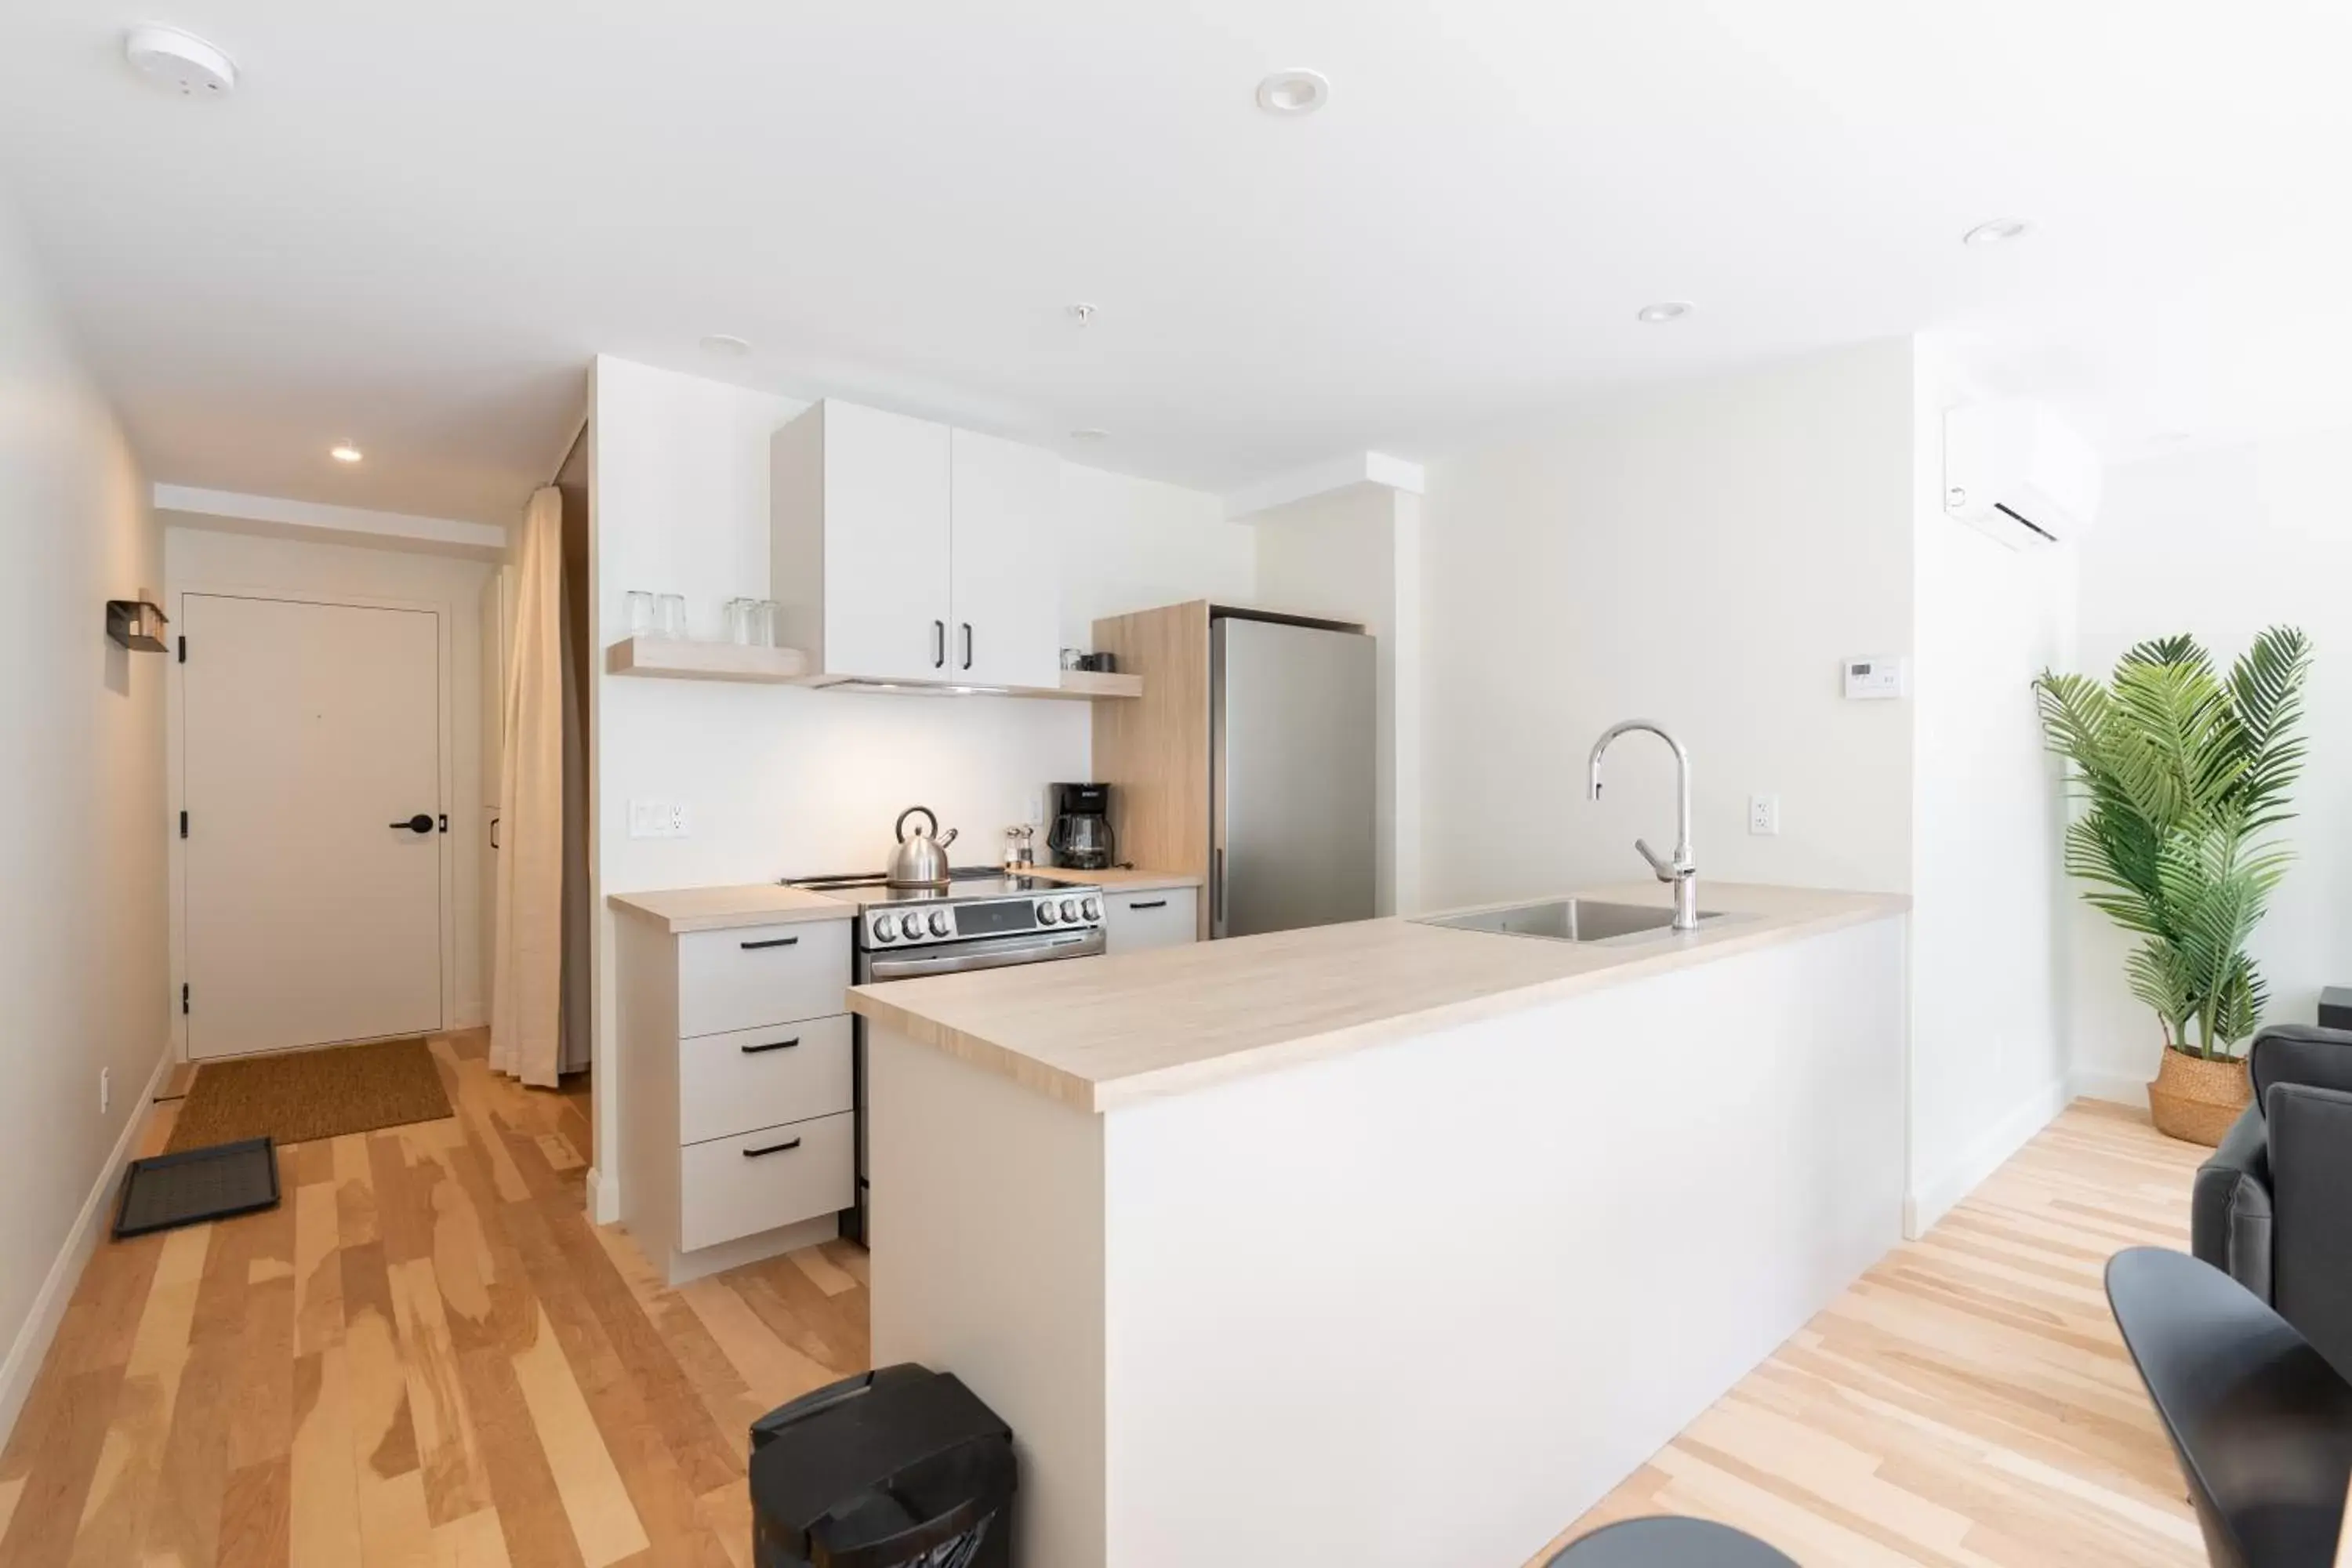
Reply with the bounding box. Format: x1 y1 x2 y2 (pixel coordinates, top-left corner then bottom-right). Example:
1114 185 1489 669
616 912 856 1286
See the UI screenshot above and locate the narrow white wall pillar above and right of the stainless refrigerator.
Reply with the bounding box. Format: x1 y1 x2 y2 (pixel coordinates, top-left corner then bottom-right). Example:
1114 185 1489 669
1251 485 1425 914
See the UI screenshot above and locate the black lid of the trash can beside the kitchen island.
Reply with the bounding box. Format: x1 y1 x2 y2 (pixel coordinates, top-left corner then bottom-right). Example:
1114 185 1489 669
750 1361 1014 1556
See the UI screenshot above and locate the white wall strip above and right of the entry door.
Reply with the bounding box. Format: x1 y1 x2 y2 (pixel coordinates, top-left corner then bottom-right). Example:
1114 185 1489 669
165 527 494 1029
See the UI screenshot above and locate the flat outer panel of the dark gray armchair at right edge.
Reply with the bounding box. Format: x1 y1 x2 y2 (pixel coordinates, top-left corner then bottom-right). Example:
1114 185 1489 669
2263 1083 2352 1373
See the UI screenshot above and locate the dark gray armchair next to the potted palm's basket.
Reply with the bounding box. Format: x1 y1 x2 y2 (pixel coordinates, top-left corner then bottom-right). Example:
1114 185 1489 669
2190 1025 2352 1377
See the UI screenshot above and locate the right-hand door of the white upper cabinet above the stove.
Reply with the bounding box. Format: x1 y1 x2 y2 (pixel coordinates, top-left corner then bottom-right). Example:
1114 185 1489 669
948 430 1061 687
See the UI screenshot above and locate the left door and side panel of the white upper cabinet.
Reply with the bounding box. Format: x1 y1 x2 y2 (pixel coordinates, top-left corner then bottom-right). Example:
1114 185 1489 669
769 400 955 680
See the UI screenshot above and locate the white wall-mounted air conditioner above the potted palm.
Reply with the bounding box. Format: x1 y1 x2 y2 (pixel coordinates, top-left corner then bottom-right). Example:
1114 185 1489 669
1943 402 2103 550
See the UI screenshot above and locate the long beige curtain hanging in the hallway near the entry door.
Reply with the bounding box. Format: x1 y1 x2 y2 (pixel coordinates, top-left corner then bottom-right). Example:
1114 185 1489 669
489 485 562 1088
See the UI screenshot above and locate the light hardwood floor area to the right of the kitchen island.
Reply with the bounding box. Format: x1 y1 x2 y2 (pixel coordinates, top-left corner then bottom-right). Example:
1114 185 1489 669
1536 1100 2206 1568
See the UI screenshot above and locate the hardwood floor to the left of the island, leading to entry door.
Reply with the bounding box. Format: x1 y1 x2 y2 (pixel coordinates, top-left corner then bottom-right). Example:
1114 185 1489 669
0 1032 868 1568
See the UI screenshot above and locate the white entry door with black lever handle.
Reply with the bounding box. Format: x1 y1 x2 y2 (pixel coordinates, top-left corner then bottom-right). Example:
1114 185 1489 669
179 593 447 1058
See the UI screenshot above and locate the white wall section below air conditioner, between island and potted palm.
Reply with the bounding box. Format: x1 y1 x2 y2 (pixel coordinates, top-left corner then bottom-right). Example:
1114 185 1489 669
1910 341 2077 1232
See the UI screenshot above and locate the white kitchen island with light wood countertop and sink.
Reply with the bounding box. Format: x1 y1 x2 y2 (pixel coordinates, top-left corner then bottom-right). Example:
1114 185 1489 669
851 884 1905 1568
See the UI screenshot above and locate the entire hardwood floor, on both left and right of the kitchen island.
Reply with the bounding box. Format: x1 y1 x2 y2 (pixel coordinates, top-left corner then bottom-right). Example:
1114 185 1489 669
0 1034 2201 1568
